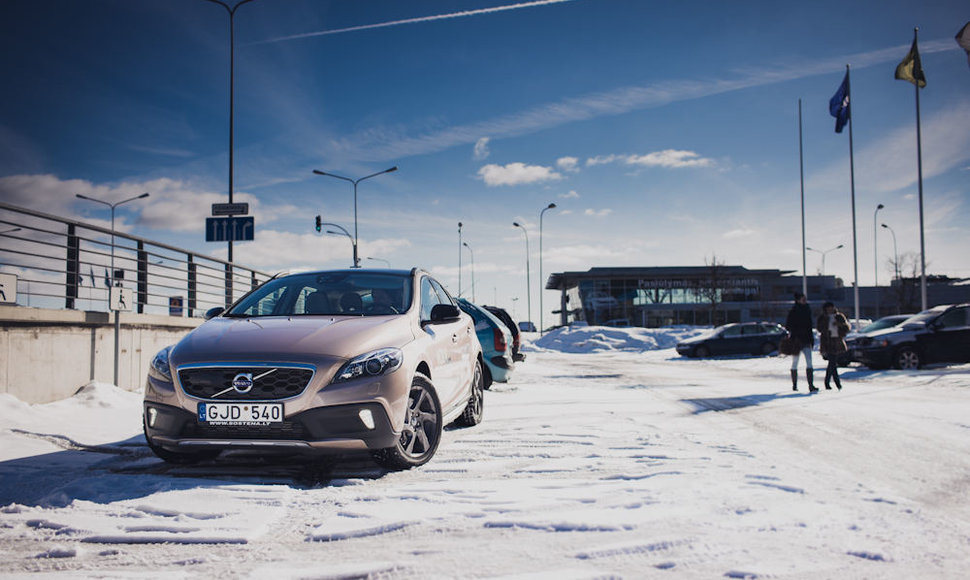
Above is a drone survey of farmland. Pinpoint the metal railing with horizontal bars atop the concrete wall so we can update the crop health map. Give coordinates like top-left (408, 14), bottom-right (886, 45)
top-left (0, 203), bottom-right (271, 318)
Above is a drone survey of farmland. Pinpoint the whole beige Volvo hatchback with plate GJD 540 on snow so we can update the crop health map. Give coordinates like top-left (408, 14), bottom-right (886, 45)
top-left (144, 269), bottom-right (484, 469)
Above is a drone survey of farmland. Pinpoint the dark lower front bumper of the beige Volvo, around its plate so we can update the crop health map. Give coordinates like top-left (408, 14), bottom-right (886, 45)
top-left (144, 401), bottom-right (401, 453)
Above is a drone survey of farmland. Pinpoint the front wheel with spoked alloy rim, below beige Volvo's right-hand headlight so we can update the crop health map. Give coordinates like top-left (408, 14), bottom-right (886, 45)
top-left (372, 374), bottom-right (442, 470)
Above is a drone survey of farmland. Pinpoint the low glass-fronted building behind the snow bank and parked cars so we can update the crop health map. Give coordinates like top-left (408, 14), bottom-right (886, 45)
top-left (546, 265), bottom-right (970, 328)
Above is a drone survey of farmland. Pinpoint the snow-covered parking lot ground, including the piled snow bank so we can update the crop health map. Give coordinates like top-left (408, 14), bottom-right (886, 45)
top-left (0, 327), bottom-right (970, 580)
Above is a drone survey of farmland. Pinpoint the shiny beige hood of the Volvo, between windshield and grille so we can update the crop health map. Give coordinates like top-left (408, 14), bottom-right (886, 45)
top-left (171, 316), bottom-right (414, 365)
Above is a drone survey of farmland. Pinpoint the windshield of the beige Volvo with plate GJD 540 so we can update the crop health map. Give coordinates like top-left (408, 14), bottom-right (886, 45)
top-left (226, 271), bottom-right (411, 317)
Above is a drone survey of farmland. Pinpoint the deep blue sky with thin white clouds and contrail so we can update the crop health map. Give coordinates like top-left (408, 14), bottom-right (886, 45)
top-left (0, 0), bottom-right (970, 322)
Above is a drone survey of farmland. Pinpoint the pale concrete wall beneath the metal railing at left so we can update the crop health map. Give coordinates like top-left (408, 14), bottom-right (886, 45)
top-left (0, 306), bottom-right (202, 403)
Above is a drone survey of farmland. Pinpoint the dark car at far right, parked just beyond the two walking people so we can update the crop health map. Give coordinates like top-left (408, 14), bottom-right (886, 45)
top-left (852, 304), bottom-right (970, 370)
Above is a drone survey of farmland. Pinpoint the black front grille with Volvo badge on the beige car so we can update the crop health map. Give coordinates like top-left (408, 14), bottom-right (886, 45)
top-left (178, 366), bottom-right (313, 401)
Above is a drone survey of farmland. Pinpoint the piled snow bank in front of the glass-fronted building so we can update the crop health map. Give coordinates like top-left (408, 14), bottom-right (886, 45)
top-left (526, 326), bottom-right (710, 353)
